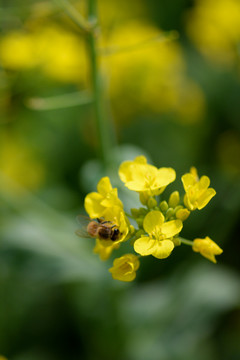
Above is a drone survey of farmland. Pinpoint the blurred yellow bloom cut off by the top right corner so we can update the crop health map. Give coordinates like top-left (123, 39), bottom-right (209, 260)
top-left (186, 0), bottom-right (240, 65)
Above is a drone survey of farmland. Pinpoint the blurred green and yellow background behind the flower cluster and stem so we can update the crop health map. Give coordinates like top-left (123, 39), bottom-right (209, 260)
top-left (0, 0), bottom-right (240, 360)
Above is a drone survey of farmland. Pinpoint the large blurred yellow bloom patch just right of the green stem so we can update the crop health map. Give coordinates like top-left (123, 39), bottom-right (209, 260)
top-left (103, 22), bottom-right (205, 122)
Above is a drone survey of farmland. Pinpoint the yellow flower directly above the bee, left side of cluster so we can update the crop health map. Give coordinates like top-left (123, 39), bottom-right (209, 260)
top-left (84, 176), bottom-right (123, 219)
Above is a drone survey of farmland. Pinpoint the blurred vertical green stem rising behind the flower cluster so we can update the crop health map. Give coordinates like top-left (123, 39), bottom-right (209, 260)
top-left (88, 0), bottom-right (111, 168)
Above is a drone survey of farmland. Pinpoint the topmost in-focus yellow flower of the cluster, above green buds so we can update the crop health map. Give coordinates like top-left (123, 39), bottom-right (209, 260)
top-left (119, 156), bottom-right (176, 196)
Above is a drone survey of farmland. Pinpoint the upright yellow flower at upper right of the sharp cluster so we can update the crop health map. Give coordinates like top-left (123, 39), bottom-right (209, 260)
top-left (182, 167), bottom-right (216, 210)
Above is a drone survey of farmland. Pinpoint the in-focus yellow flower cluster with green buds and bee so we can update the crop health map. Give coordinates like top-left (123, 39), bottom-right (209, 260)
top-left (77, 156), bottom-right (222, 281)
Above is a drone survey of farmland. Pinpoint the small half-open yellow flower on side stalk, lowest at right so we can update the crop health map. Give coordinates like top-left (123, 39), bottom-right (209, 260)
top-left (193, 236), bottom-right (223, 264)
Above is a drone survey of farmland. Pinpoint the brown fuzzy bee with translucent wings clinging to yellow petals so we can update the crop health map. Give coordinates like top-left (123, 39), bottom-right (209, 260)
top-left (75, 215), bottom-right (122, 241)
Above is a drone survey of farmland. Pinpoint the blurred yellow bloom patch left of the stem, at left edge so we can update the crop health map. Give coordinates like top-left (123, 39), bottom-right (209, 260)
top-left (0, 24), bottom-right (88, 84)
